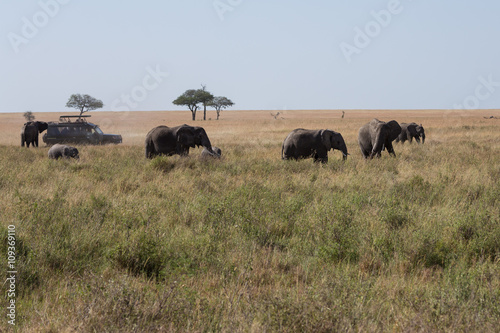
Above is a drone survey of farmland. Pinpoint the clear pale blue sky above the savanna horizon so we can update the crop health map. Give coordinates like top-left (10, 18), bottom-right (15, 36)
top-left (0, 0), bottom-right (500, 112)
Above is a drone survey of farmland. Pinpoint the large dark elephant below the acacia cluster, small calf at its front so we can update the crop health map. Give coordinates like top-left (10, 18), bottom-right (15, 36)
top-left (145, 124), bottom-right (214, 158)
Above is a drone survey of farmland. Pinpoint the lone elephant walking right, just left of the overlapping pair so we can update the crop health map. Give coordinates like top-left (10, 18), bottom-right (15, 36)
top-left (281, 128), bottom-right (349, 163)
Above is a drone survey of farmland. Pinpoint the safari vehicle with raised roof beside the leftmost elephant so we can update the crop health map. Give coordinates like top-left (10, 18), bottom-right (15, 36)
top-left (43, 115), bottom-right (122, 145)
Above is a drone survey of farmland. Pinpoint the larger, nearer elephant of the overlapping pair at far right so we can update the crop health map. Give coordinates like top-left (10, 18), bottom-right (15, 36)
top-left (358, 119), bottom-right (401, 158)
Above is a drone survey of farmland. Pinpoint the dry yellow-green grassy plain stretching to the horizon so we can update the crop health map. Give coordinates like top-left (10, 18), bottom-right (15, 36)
top-left (0, 110), bottom-right (500, 332)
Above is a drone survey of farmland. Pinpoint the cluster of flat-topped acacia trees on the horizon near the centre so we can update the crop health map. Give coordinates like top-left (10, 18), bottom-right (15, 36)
top-left (172, 85), bottom-right (234, 120)
